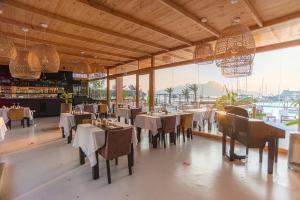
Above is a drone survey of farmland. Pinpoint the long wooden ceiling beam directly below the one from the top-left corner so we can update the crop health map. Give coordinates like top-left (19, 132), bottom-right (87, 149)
top-left (0, 16), bottom-right (150, 55)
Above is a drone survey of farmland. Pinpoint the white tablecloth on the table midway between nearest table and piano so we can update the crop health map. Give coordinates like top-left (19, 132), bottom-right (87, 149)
top-left (134, 112), bottom-right (183, 136)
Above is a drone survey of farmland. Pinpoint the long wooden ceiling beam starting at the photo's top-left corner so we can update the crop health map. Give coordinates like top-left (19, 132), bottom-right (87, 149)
top-left (1, 0), bottom-right (169, 51)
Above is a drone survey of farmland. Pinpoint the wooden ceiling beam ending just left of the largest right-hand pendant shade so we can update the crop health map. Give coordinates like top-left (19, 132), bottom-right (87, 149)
top-left (159, 0), bottom-right (220, 37)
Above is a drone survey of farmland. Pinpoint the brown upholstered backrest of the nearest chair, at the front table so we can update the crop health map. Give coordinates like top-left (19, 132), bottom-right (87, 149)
top-left (103, 127), bottom-right (133, 160)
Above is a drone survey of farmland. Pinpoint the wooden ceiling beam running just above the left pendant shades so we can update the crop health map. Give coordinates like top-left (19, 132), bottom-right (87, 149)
top-left (0, 31), bottom-right (121, 62)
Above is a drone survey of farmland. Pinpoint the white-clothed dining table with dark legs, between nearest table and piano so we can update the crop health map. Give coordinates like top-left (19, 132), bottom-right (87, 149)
top-left (134, 112), bottom-right (188, 148)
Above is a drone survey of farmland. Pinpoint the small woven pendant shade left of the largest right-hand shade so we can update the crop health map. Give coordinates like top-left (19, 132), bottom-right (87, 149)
top-left (194, 43), bottom-right (214, 65)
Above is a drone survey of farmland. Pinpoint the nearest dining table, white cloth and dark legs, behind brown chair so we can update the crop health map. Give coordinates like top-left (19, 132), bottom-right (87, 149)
top-left (73, 121), bottom-right (137, 180)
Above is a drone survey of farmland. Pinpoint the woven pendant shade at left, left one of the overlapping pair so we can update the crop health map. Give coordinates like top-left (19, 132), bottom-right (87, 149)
top-left (9, 51), bottom-right (41, 80)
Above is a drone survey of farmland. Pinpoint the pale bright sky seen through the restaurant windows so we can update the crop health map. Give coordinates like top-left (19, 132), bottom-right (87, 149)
top-left (120, 46), bottom-right (300, 95)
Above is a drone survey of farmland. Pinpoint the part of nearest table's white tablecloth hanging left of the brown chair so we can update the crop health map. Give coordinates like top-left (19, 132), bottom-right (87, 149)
top-left (73, 124), bottom-right (105, 167)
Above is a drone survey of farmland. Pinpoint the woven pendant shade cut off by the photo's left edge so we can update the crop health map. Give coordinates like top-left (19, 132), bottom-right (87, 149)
top-left (0, 35), bottom-right (17, 60)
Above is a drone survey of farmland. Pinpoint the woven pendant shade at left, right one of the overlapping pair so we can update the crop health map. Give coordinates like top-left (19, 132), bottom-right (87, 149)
top-left (28, 44), bottom-right (60, 73)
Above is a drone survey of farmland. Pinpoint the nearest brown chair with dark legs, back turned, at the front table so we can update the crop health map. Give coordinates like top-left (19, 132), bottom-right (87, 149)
top-left (98, 128), bottom-right (133, 184)
